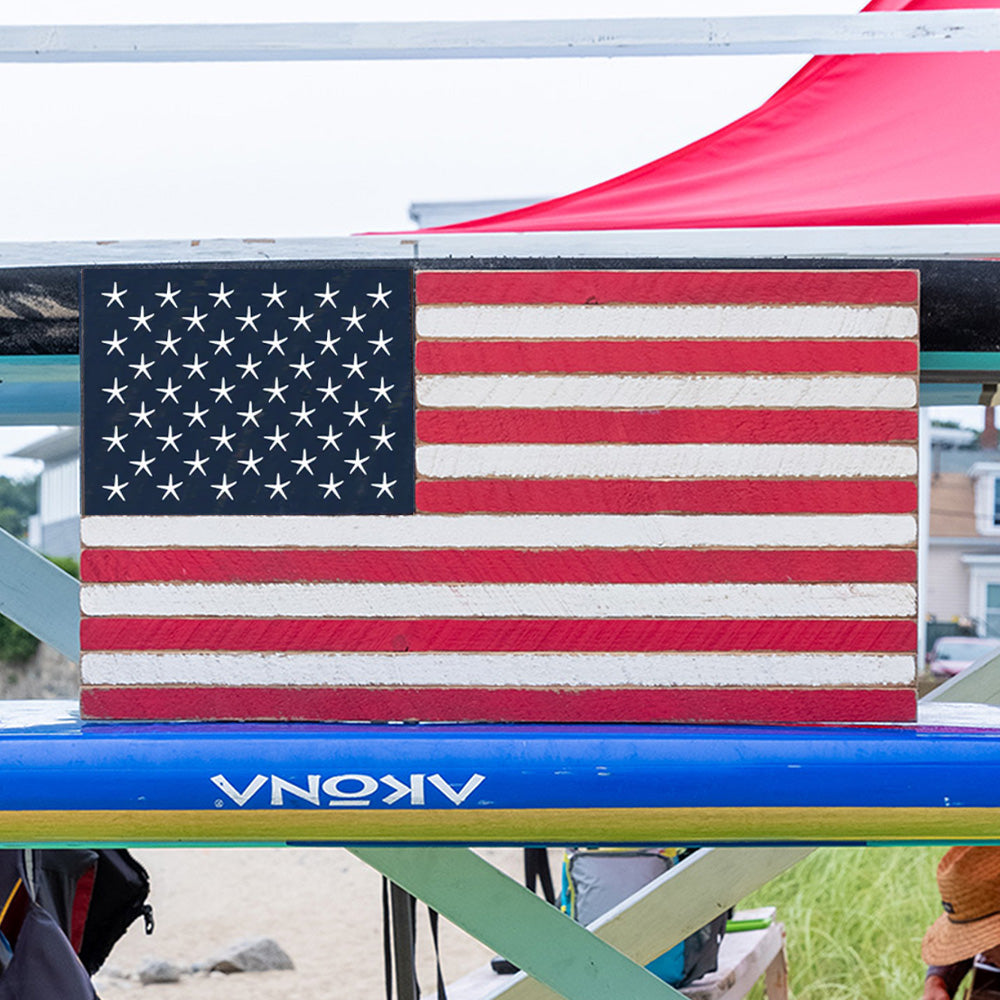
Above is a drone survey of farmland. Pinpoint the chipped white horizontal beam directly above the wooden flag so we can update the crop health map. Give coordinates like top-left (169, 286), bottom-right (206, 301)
top-left (0, 225), bottom-right (1000, 269)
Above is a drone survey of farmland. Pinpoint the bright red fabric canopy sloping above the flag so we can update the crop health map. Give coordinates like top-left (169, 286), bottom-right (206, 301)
top-left (425, 0), bottom-right (1000, 233)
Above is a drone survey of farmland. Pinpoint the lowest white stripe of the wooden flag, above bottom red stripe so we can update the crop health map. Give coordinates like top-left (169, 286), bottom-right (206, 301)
top-left (81, 653), bottom-right (916, 687)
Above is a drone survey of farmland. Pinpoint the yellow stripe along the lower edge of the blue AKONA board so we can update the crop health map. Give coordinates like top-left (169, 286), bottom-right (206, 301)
top-left (0, 807), bottom-right (1000, 846)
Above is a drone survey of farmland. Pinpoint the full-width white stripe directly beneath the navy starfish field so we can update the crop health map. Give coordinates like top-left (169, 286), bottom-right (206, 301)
top-left (81, 516), bottom-right (917, 549)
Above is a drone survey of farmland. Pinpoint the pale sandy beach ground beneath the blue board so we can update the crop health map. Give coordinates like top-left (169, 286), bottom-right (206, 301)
top-left (95, 848), bottom-right (521, 1000)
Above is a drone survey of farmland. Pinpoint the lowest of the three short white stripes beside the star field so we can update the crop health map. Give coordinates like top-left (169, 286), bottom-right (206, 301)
top-left (417, 444), bottom-right (917, 479)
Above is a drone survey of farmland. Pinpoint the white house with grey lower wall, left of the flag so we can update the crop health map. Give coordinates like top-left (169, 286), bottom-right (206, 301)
top-left (12, 427), bottom-right (80, 558)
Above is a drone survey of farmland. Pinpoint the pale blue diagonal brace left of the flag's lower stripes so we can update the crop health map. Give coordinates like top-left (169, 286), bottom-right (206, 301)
top-left (0, 528), bottom-right (80, 660)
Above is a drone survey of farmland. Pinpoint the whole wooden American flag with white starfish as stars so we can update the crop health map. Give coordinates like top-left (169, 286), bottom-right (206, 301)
top-left (82, 265), bottom-right (918, 721)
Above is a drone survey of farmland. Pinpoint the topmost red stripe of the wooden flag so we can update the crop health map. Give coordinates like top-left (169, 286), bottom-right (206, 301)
top-left (416, 271), bottom-right (918, 305)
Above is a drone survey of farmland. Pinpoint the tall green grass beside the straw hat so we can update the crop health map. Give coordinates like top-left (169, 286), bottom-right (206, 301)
top-left (740, 847), bottom-right (946, 1000)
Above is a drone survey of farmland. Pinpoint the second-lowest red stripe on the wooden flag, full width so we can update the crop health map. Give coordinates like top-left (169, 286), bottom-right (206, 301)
top-left (80, 618), bottom-right (917, 653)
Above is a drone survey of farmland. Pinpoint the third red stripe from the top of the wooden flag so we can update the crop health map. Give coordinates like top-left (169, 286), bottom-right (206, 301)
top-left (417, 409), bottom-right (917, 444)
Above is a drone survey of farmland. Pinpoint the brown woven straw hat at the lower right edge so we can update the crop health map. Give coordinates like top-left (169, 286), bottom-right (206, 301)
top-left (921, 847), bottom-right (1000, 965)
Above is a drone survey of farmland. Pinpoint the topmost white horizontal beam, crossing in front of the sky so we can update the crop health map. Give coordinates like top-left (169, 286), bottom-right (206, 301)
top-left (0, 10), bottom-right (1000, 63)
